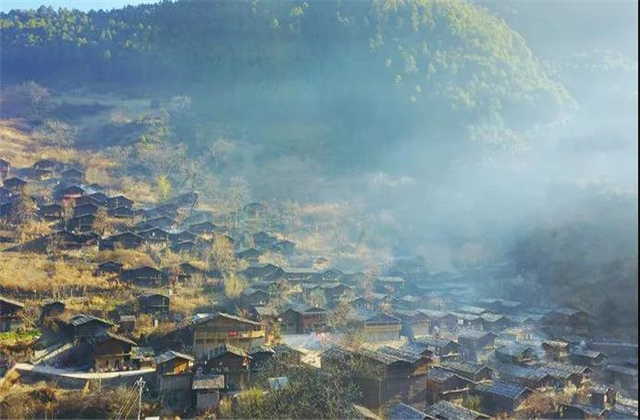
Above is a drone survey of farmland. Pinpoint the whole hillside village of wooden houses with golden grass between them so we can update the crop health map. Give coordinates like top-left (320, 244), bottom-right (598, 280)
top-left (0, 158), bottom-right (638, 420)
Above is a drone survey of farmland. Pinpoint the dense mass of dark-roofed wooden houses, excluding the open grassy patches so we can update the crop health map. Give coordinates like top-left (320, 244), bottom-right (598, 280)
top-left (0, 159), bottom-right (638, 420)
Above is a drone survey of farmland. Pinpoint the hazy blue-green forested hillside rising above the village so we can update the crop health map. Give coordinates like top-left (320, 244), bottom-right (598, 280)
top-left (0, 0), bottom-right (569, 164)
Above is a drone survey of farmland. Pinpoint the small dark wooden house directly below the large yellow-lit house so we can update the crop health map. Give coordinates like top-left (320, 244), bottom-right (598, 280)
top-left (205, 344), bottom-right (251, 391)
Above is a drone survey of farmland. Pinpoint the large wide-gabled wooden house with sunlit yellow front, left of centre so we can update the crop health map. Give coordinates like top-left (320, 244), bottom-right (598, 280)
top-left (192, 312), bottom-right (265, 358)
